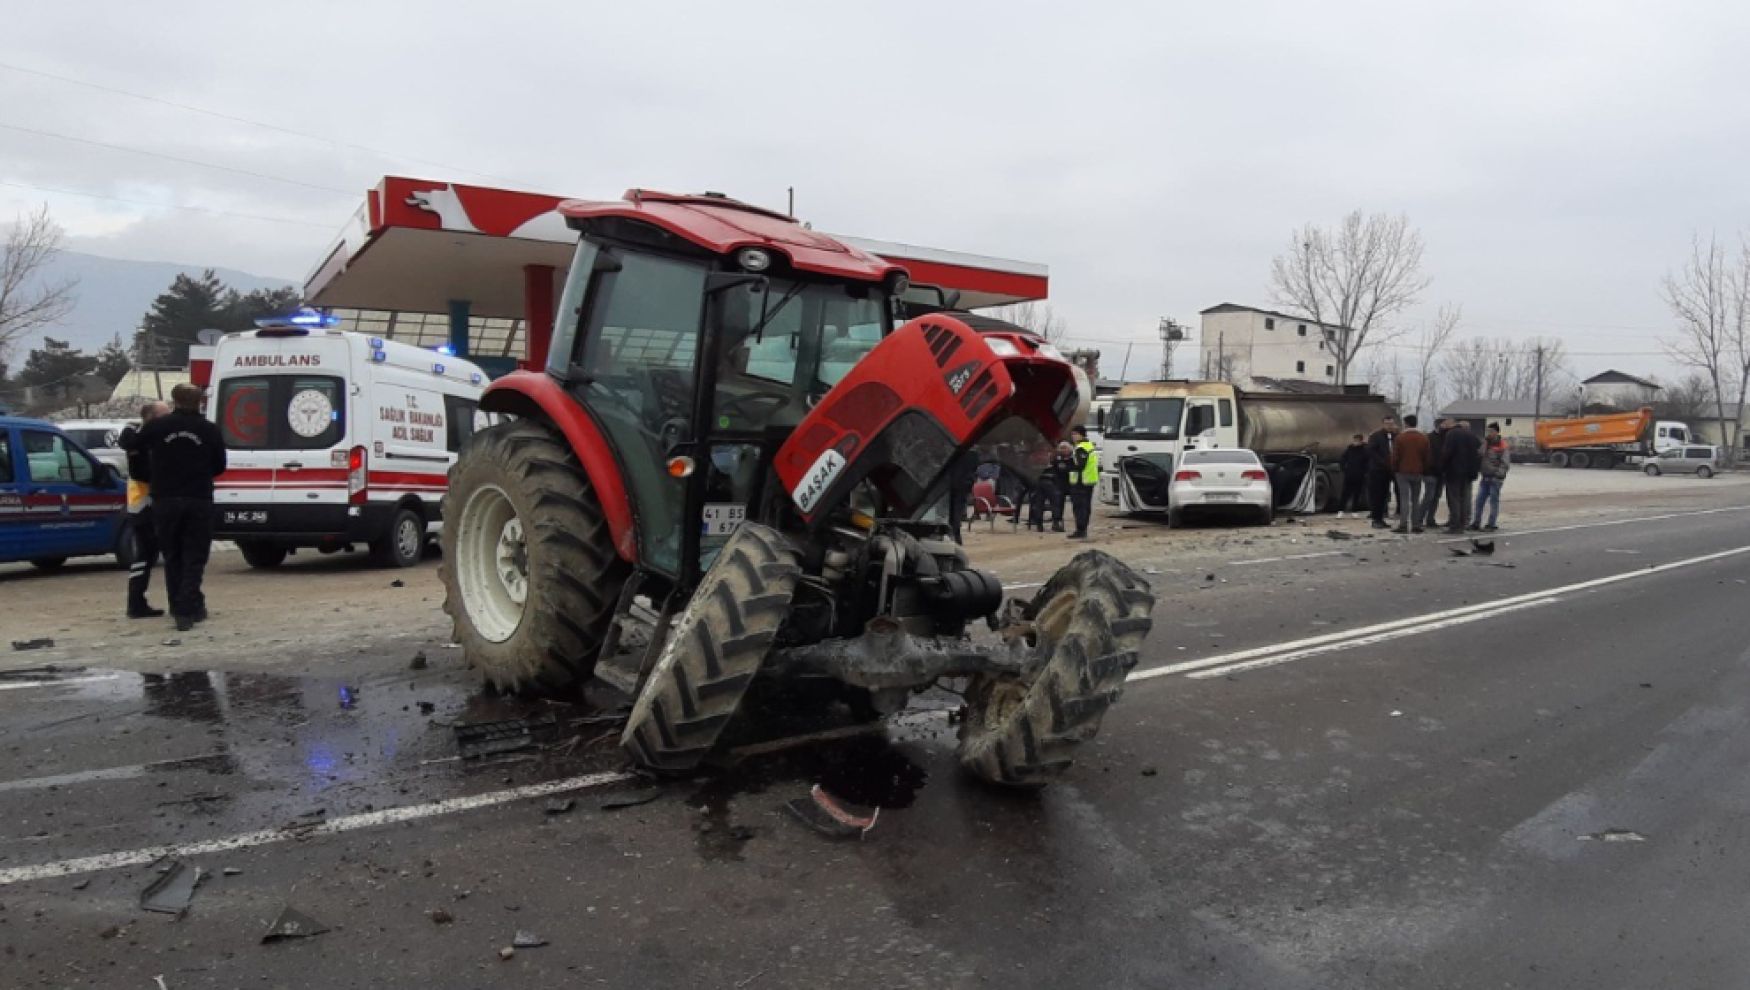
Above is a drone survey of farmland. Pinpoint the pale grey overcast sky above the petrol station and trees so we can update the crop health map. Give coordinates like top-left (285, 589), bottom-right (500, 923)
top-left (0, 0), bottom-right (1750, 388)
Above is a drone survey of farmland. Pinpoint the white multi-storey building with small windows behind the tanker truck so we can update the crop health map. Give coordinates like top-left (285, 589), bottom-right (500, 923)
top-left (1197, 303), bottom-right (1337, 388)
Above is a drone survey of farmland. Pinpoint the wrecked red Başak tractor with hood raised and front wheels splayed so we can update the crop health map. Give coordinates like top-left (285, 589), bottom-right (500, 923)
top-left (443, 189), bottom-right (1153, 785)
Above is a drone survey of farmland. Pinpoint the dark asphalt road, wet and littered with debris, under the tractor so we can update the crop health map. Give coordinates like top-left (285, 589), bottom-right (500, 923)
top-left (0, 488), bottom-right (1750, 990)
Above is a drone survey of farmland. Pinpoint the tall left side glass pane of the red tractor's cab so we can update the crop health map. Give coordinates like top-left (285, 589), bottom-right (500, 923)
top-left (579, 254), bottom-right (705, 574)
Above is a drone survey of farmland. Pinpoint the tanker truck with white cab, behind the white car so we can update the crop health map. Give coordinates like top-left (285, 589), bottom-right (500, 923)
top-left (1099, 381), bottom-right (1395, 514)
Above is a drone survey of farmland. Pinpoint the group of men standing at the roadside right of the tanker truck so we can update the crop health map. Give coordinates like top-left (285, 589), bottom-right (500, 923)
top-left (1339, 415), bottom-right (1512, 533)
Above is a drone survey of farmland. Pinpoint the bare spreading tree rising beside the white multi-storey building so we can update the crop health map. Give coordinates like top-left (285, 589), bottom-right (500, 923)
top-left (1271, 210), bottom-right (1428, 385)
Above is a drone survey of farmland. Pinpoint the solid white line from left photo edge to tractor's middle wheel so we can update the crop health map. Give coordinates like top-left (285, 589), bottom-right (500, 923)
top-left (0, 771), bottom-right (639, 887)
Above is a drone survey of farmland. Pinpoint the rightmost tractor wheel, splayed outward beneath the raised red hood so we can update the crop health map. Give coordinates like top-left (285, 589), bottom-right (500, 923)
top-left (959, 549), bottom-right (1155, 787)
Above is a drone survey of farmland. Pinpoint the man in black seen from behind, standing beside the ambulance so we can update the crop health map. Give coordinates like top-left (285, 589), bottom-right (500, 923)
top-left (135, 385), bottom-right (226, 631)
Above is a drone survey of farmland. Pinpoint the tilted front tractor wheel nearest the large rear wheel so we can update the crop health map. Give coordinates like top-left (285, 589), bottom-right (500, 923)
top-left (620, 523), bottom-right (802, 771)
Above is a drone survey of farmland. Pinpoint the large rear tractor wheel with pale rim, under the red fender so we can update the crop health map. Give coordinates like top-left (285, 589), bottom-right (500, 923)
top-left (439, 420), bottom-right (628, 691)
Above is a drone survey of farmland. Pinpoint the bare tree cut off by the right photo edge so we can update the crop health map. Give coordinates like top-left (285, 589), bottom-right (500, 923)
top-left (1663, 234), bottom-right (1747, 450)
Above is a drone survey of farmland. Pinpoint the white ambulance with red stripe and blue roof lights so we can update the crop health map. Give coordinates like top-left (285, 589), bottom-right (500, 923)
top-left (207, 310), bottom-right (487, 567)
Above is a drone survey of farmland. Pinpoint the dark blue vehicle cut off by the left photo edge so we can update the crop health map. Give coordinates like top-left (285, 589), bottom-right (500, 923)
top-left (0, 416), bottom-right (133, 570)
